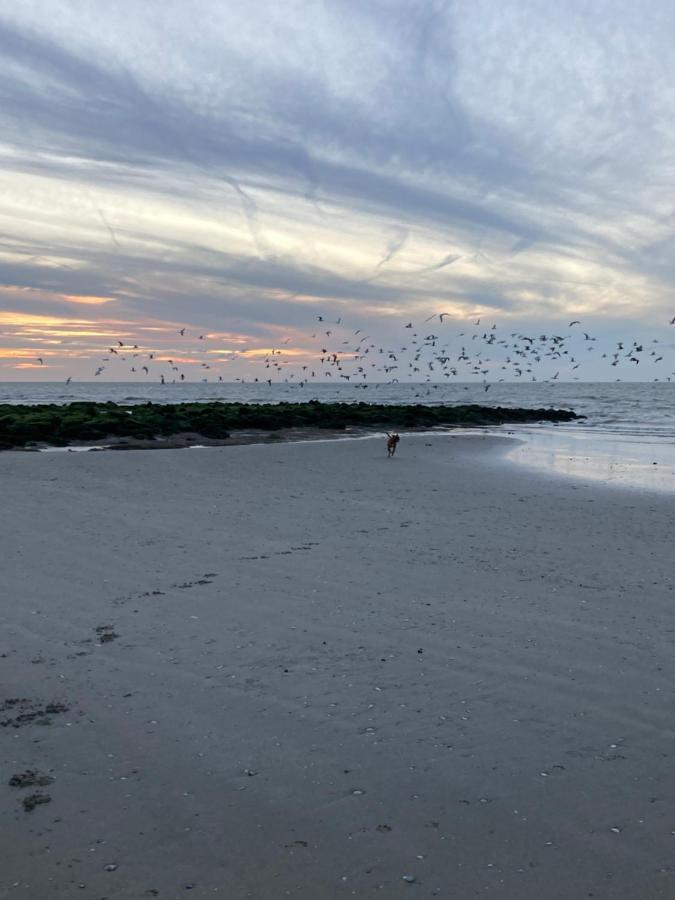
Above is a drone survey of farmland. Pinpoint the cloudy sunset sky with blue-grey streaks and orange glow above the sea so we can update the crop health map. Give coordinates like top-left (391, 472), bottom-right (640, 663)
top-left (0, 0), bottom-right (675, 381)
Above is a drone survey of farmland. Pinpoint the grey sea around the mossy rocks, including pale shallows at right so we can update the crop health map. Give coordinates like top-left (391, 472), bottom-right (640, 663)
top-left (0, 381), bottom-right (675, 493)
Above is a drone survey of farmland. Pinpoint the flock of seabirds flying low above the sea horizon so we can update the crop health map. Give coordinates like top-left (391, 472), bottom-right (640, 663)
top-left (37, 312), bottom-right (675, 391)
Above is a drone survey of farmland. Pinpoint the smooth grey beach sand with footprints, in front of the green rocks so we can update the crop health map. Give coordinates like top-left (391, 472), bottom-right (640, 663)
top-left (0, 436), bottom-right (675, 900)
